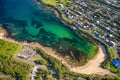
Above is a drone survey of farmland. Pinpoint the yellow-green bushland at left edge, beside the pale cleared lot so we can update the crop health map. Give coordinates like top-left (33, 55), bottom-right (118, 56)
top-left (0, 39), bottom-right (30, 80)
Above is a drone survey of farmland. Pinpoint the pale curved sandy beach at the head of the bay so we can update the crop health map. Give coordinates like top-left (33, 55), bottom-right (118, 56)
top-left (71, 45), bottom-right (112, 75)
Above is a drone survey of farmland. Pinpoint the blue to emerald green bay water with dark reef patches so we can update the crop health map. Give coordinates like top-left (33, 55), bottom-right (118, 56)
top-left (0, 0), bottom-right (96, 60)
